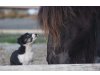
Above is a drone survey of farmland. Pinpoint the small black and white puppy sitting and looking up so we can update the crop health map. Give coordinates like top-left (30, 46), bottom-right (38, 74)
top-left (10, 33), bottom-right (37, 65)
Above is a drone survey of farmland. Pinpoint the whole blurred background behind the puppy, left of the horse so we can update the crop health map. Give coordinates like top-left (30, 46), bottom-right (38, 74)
top-left (0, 6), bottom-right (47, 65)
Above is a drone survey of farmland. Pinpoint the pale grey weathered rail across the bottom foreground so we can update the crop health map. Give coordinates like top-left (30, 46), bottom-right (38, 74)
top-left (0, 64), bottom-right (100, 71)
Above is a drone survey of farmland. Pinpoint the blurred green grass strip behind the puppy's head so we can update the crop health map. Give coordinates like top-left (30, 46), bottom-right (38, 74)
top-left (0, 34), bottom-right (47, 43)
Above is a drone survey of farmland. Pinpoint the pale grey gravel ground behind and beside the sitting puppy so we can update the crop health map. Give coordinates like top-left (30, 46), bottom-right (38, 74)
top-left (0, 43), bottom-right (47, 65)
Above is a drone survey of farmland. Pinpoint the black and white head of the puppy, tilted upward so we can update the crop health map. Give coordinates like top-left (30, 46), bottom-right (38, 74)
top-left (17, 33), bottom-right (37, 45)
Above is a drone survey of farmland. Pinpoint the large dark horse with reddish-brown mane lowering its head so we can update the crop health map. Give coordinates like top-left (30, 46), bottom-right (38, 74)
top-left (38, 6), bottom-right (100, 64)
